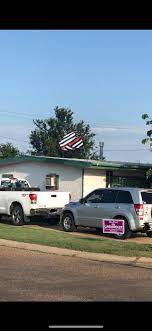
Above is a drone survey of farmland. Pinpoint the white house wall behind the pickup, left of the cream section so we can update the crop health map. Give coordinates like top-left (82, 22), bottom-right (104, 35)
top-left (0, 162), bottom-right (82, 201)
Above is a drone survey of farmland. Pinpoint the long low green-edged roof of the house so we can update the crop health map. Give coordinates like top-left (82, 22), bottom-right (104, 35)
top-left (0, 155), bottom-right (152, 170)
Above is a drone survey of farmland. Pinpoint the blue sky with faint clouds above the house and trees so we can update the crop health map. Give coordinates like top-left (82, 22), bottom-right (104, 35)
top-left (0, 30), bottom-right (152, 163)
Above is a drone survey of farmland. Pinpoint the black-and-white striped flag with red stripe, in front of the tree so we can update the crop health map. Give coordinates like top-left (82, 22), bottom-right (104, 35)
top-left (59, 131), bottom-right (83, 151)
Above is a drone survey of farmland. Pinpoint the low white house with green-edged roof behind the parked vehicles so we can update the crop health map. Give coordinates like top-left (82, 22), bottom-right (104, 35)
top-left (0, 155), bottom-right (152, 201)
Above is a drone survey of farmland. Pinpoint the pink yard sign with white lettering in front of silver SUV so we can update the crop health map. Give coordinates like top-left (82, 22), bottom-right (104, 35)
top-left (103, 219), bottom-right (125, 234)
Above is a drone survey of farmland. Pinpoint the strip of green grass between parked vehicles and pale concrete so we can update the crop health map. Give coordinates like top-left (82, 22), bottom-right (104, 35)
top-left (0, 223), bottom-right (152, 257)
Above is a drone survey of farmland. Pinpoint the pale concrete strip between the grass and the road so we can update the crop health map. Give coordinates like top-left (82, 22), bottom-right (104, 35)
top-left (0, 239), bottom-right (152, 269)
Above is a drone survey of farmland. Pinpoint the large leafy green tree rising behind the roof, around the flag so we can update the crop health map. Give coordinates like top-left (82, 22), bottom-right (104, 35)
top-left (30, 106), bottom-right (101, 159)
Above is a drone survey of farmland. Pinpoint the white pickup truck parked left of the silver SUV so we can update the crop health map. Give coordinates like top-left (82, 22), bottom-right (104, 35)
top-left (0, 178), bottom-right (70, 225)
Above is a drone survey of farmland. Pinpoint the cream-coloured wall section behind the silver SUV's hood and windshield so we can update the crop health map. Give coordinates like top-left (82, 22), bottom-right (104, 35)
top-left (83, 169), bottom-right (106, 196)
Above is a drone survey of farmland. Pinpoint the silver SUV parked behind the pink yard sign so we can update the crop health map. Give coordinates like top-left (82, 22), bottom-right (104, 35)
top-left (60, 187), bottom-right (152, 239)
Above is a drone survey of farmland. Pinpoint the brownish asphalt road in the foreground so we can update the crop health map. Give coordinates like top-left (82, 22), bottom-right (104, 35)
top-left (0, 246), bottom-right (152, 301)
